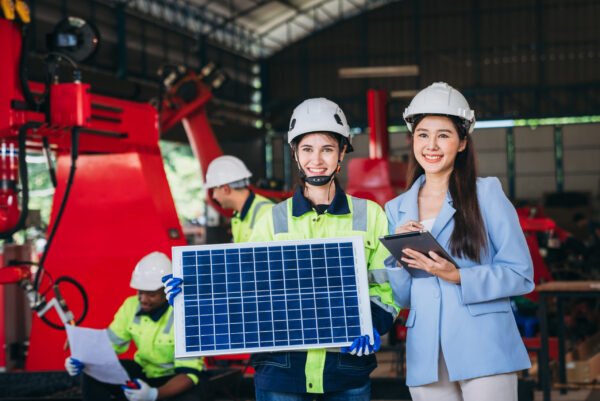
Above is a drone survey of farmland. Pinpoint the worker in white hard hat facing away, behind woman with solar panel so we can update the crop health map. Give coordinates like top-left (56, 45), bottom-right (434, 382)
top-left (204, 156), bottom-right (273, 243)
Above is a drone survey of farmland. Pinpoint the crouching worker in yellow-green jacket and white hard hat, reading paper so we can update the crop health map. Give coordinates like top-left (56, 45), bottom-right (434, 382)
top-left (65, 252), bottom-right (204, 401)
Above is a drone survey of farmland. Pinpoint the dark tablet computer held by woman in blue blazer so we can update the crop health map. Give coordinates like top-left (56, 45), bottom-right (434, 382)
top-left (379, 231), bottom-right (458, 277)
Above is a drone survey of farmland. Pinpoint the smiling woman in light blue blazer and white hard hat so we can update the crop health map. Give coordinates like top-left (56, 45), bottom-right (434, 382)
top-left (385, 82), bottom-right (534, 401)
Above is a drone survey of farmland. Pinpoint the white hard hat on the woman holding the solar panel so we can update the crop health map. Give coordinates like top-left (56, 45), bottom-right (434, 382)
top-left (288, 97), bottom-right (352, 152)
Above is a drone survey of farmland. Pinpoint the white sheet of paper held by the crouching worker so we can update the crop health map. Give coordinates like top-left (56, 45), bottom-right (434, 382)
top-left (66, 325), bottom-right (129, 384)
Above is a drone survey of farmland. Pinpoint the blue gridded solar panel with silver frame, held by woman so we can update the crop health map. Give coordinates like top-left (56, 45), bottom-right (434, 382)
top-left (173, 237), bottom-right (373, 357)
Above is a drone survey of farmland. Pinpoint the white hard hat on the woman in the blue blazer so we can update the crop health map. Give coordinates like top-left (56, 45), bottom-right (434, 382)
top-left (402, 82), bottom-right (475, 133)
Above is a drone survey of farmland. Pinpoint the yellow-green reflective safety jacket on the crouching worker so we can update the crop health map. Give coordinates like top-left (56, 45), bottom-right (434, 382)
top-left (107, 295), bottom-right (204, 384)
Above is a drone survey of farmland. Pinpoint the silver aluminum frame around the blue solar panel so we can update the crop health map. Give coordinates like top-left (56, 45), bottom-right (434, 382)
top-left (172, 236), bottom-right (373, 358)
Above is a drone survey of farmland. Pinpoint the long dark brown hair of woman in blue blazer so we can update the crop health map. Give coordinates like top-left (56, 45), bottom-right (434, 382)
top-left (407, 114), bottom-right (488, 262)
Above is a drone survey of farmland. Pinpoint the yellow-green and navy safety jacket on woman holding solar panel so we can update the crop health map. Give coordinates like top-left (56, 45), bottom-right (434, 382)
top-left (250, 188), bottom-right (399, 393)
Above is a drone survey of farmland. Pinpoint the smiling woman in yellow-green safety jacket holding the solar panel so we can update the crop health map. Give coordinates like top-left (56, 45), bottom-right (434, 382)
top-left (166, 98), bottom-right (398, 401)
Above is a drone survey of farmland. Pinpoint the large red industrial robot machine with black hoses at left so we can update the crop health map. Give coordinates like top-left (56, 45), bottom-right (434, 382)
top-left (0, 4), bottom-right (282, 371)
